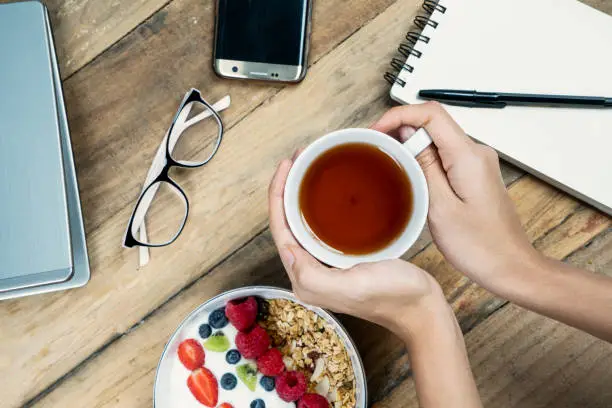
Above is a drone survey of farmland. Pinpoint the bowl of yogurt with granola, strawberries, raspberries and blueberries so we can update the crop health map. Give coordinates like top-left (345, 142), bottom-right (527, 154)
top-left (153, 286), bottom-right (367, 408)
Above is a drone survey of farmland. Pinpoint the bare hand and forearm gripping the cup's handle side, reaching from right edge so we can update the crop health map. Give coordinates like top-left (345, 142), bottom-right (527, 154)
top-left (372, 103), bottom-right (612, 342)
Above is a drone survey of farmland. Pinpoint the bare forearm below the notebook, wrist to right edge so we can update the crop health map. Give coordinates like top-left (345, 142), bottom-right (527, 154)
top-left (493, 256), bottom-right (612, 342)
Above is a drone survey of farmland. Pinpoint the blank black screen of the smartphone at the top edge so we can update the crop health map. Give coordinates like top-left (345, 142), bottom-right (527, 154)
top-left (216, 0), bottom-right (308, 65)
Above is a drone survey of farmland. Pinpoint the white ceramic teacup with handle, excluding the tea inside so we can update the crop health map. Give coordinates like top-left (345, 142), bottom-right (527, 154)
top-left (284, 129), bottom-right (431, 268)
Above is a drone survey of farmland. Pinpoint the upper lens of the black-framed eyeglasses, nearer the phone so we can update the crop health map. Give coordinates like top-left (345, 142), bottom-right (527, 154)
top-left (170, 102), bottom-right (221, 165)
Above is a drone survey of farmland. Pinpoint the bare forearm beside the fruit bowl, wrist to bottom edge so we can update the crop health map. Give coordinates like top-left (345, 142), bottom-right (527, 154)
top-left (398, 300), bottom-right (482, 408)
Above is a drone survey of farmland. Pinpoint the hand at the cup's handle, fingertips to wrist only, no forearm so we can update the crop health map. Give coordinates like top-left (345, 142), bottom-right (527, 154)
top-left (372, 102), bottom-right (541, 293)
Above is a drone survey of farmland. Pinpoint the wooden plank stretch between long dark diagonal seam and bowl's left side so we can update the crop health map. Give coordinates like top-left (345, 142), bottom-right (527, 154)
top-left (34, 233), bottom-right (290, 408)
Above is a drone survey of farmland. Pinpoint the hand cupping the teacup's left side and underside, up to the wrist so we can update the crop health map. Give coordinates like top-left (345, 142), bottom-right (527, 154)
top-left (269, 160), bottom-right (452, 337)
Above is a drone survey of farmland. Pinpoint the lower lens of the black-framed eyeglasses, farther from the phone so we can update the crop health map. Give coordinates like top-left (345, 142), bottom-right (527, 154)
top-left (132, 181), bottom-right (187, 245)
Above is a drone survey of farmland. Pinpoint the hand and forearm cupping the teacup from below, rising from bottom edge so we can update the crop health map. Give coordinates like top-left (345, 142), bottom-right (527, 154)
top-left (269, 151), bottom-right (482, 408)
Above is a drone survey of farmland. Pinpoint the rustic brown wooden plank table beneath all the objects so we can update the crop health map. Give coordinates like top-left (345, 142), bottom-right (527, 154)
top-left (0, 0), bottom-right (612, 408)
